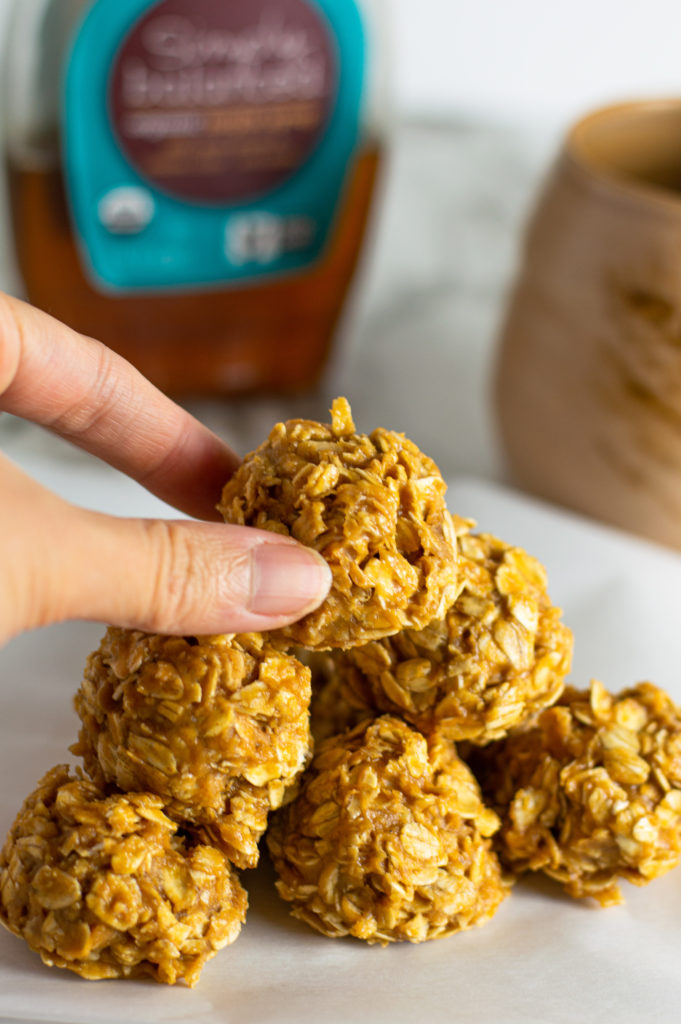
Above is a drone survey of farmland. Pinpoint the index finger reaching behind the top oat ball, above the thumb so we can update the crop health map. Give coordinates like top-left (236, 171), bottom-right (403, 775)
top-left (0, 294), bottom-right (239, 519)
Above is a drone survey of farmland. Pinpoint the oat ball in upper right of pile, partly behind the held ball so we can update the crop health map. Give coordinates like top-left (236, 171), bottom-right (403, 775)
top-left (331, 519), bottom-right (572, 743)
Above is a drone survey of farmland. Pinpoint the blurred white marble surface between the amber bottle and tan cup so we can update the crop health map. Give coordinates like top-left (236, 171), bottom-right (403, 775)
top-left (0, 122), bottom-right (558, 499)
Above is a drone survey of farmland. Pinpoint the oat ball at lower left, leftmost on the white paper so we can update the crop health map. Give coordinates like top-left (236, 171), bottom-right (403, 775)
top-left (0, 765), bottom-right (247, 985)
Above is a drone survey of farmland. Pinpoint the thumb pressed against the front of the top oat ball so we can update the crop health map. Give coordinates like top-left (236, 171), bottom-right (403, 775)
top-left (0, 468), bottom-right (331, 640)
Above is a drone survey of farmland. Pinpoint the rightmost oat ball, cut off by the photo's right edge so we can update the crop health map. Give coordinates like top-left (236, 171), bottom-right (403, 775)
top-left (475, 682), bottom-right (681, 906)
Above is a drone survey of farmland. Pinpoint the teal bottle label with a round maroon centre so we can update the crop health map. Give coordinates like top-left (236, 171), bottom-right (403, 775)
top-left (62, 0), bottom-right (366, 291)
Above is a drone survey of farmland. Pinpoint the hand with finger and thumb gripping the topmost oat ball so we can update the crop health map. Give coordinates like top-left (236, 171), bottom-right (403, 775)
top-left (0, 295), bottom-right (331, 644)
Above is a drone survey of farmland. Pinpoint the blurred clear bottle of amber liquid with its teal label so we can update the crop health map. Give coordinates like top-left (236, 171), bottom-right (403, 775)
top-left (5, 0), bottom-right (384, 394)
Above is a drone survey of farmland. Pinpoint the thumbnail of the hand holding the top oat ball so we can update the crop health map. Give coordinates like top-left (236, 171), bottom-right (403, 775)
top-left (249, 544), bottom-right (331, 616)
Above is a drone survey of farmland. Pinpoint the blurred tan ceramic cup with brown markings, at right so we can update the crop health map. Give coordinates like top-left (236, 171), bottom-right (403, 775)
top-left (495, 99), bottom-right (681, 548)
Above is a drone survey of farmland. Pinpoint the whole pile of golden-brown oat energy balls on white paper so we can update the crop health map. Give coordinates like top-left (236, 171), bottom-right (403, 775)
top-left (0, 398), bottom-right (681, 985)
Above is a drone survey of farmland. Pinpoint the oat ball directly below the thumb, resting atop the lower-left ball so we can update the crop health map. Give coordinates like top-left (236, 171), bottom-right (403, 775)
top-left (73, 629), bottom-right (311, 867)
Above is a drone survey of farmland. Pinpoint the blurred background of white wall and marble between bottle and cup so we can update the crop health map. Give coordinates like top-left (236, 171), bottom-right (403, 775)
top-left (0, 0), bottom-right (681, 499)
